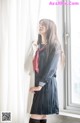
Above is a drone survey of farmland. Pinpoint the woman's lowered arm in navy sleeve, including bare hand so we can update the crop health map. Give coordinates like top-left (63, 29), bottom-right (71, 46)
top-left (30, 52), bottom-right (59, 93)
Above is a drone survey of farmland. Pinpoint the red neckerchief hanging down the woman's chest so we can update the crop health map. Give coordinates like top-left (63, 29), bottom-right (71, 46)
top-left (33, 46), bottom-right (45, 73)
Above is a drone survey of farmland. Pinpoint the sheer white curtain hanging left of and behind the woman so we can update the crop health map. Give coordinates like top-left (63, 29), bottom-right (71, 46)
top-left (0, 0), bottom-right (56, 123)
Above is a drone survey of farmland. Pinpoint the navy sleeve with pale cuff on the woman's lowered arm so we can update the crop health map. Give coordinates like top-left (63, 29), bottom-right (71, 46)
top-left (39, 46), bottom-right (60, 87)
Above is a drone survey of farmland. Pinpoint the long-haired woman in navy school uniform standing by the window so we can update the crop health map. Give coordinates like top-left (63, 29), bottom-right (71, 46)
top-left (24, 19), bottom-right (62, 123)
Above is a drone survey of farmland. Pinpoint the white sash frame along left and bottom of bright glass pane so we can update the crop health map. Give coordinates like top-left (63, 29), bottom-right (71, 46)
top-left (63, 0), bottom-right (80, 114)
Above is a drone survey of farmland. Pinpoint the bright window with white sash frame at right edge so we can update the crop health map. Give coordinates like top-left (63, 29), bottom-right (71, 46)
top-left (63, 0), bottom-right (80, 113)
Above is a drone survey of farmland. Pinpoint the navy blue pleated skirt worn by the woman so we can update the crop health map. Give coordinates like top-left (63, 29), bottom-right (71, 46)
top-left (30, 77), bottom-right (59, 115)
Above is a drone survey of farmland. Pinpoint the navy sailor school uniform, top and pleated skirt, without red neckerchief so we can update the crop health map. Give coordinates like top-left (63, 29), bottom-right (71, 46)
top-left (24, 44), bottom-right (60, 115)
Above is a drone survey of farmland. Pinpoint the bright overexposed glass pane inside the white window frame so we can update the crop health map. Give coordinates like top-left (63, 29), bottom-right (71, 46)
top-left (71, 6), bottom-right (80, 105)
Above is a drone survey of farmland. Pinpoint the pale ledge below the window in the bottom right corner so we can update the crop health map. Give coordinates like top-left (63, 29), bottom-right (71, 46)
top-left (47, 115), bottom-right (80, 123)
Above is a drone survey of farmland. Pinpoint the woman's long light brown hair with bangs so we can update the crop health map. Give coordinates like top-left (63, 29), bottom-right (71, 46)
top-left (37, 19), bottom-right (63, 65)
